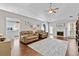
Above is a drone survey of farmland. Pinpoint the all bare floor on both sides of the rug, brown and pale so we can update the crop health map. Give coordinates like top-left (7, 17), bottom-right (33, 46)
top-left (12, 36), bottom-right (78, 56)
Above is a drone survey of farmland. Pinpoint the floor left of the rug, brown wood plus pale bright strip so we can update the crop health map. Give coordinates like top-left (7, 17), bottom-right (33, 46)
top-left (11, 39), bottom-right (41, 56)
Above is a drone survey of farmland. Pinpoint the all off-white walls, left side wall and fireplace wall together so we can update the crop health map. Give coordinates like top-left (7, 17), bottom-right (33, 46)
top-left (0, 10), bottom-right (76, 37)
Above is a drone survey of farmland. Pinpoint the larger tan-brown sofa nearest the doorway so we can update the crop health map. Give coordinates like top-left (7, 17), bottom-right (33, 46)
top-left (20, 31), bottom-right (39, 44)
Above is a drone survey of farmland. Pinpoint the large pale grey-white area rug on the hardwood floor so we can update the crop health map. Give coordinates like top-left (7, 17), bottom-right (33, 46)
top-left (28, 38), bottom-right (68, 56)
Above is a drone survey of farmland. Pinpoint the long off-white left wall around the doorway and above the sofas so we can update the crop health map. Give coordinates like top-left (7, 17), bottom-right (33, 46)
top-left (0, 10), bottom-right (42, 35)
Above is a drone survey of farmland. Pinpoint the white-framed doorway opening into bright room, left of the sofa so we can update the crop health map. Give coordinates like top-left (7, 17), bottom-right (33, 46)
top-left (6, 18), bottom-right (20, 39)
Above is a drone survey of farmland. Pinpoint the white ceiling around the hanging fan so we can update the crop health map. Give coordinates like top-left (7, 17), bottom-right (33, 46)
top-left (0, 3), bottom-right (79, 22)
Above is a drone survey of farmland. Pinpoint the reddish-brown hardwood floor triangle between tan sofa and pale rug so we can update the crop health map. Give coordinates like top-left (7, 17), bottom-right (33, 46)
top-left (20, 43), bottom-right (41, 56)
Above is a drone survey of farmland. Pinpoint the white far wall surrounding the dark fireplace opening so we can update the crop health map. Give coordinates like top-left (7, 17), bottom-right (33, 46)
top-left (49, 20), bottom-right (76, 37)
